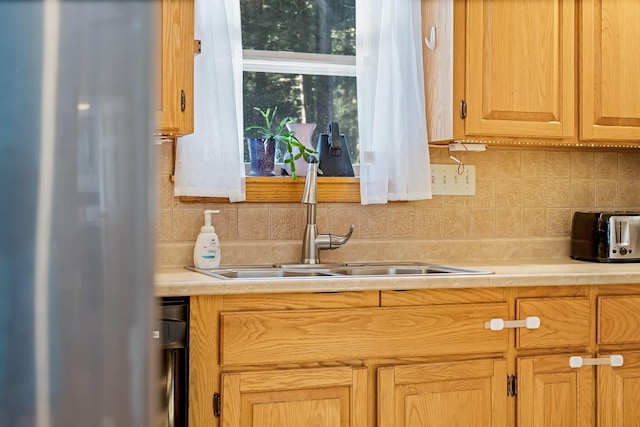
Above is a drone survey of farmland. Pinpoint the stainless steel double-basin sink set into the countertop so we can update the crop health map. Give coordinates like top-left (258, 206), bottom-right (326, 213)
top-left (186, 263), bottom-right (493, 280)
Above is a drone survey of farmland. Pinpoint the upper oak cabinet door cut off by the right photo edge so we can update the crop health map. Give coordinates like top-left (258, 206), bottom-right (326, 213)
top-left (580, 0), bottom-right (640, 140)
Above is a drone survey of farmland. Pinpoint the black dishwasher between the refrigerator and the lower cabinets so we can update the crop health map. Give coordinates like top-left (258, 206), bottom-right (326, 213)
top-left (153, 297), bottom-right (189, 427)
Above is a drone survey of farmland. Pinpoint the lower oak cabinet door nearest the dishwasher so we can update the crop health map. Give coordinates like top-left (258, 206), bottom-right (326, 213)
top-left (221, 367), bottom-right (367, 427)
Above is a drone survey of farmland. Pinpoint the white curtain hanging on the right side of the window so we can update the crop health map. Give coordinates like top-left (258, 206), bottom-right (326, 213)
top-left (356, 0), bottom-right (431, 205)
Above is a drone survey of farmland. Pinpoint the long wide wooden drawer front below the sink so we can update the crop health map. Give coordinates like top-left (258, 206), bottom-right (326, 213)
top-left (221, 303), bottom-right (508, 366)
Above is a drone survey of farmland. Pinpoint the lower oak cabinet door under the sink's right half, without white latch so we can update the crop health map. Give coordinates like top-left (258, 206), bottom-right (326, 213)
top-left (378, 360), bottom-right (507, 427)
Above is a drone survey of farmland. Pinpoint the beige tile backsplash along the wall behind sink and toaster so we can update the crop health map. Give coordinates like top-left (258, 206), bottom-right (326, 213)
top-left (156, 143), bottom-right (640, 267)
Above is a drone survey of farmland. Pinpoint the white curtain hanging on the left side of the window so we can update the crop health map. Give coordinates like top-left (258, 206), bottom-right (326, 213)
top-left (174, 0), bottom-right (245, 202)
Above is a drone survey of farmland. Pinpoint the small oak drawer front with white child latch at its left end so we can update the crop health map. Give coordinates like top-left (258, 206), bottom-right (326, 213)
top-left (517, 298), bottom-right (590, 348)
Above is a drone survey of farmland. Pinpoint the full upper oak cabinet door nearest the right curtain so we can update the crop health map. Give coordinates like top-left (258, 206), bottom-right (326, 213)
top-left (465, 0), bottom-right (576, 138)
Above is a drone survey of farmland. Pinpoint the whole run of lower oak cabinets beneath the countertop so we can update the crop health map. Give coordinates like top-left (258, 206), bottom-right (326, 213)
top-left (189, 285), bottom-right (640, 427)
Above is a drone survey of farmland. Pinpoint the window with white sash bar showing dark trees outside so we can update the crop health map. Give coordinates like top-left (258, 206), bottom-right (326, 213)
top-left (240, 0), bottom-right (359, 163)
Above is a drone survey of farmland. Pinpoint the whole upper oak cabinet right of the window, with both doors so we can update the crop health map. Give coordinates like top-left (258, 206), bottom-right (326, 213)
top-left (422, 0), bottom-right (640, 146)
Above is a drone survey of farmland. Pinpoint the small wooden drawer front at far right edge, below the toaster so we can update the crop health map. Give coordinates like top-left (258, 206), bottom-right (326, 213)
top-left (598, 296), bottom-right (640, 344)
